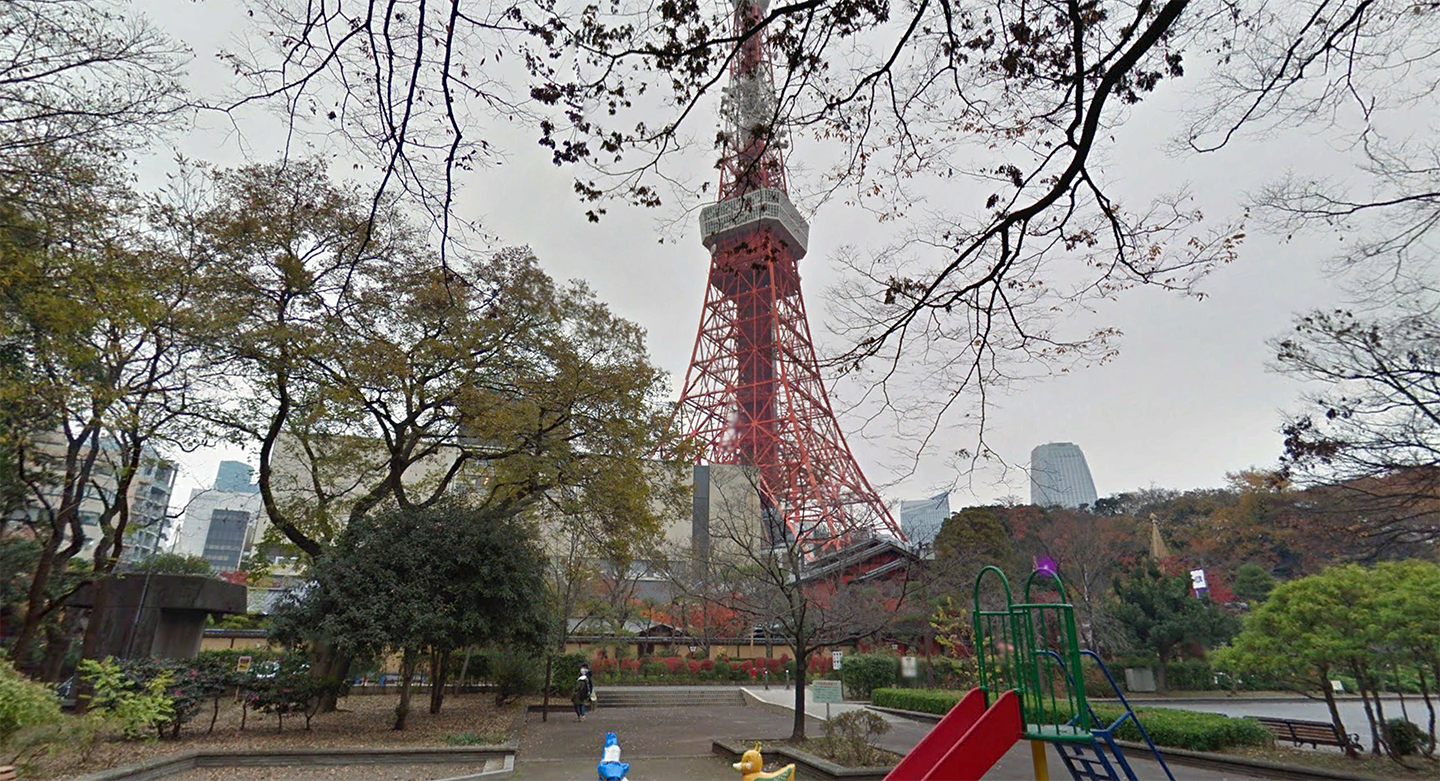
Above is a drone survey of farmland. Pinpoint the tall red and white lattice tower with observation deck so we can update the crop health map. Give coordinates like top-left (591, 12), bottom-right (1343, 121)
top-left (677, 0), bottom-right (903, 549)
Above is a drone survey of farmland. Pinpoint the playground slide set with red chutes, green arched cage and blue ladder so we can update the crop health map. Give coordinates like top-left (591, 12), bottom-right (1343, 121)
top-left (881, 566), bottom-right (1175, 781)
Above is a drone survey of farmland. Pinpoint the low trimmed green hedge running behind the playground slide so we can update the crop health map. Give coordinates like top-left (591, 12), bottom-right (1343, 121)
top-left (871, 689), bottom-right (1272, 751)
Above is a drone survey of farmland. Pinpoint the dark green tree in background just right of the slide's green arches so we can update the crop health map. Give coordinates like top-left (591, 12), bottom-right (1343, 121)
top-left (1115, 561), bottom-right (1240, 690)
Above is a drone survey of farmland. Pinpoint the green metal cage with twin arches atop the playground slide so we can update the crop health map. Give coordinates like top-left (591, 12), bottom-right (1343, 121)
top-left (972, 566), bottom-right (1097, 742)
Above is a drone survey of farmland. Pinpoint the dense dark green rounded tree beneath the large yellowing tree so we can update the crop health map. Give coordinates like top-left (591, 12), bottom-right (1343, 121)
top-left (275, 500), bottom-right (546, 729)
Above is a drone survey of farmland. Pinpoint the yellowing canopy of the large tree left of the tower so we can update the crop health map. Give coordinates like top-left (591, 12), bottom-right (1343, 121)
top-left (168, 160), bottom-right (682, 558)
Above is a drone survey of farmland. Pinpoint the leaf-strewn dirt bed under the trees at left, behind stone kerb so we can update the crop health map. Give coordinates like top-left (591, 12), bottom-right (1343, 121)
top-left (30, 695), bottom-right (524, 780)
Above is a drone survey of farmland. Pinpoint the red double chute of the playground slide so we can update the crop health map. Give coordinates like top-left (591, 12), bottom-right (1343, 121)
top-left (886, 689), bottom-right (1022, 781)
